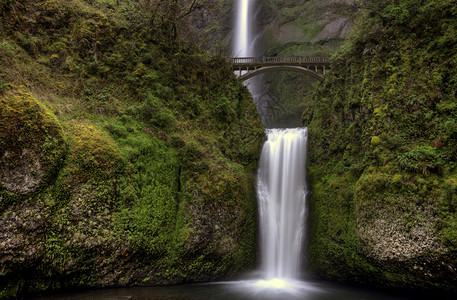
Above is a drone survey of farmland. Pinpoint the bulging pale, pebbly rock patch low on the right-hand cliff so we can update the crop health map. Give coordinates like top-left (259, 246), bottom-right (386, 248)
top-left (355, 170), bottom-right (449, 262)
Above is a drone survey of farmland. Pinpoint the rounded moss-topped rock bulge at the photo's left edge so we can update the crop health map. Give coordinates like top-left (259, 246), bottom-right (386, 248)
top-left (0, 87), bottom-right (65, 195)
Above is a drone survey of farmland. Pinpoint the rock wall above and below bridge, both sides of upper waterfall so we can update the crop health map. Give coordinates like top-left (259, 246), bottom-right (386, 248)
top-left (184, 0), bottom-right (353, 127)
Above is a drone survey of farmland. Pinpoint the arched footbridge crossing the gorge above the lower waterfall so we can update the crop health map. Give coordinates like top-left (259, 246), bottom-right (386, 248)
top-left (230, 56), bottom-right (330, 81)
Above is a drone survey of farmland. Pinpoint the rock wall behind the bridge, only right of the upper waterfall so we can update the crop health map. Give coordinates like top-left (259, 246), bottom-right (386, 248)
top-left (249, 0), bottom-right (352, 127)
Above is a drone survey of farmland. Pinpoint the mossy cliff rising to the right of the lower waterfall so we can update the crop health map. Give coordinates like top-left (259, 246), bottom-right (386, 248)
top-left (304, 0), bottom-right (457, 290)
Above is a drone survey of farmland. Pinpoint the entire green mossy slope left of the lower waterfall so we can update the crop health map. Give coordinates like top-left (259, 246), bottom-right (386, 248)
top-left (0, 0), bottom-right (263, 298)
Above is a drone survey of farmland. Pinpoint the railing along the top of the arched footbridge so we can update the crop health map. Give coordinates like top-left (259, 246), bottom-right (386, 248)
top-left (230, 56), bottom-right (330, 66)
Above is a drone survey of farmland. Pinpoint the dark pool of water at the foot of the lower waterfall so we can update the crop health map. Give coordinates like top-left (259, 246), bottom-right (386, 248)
top-left (30, 280), bottom-right (428, 300)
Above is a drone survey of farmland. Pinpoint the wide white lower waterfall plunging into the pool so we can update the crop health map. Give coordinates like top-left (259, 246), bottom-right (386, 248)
top-left (257, 128), bottom-right (308, 280)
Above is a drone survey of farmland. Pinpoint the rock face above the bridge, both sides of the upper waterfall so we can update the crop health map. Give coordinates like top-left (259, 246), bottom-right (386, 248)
top-left (184, 0), bottom-right (352, 55)
